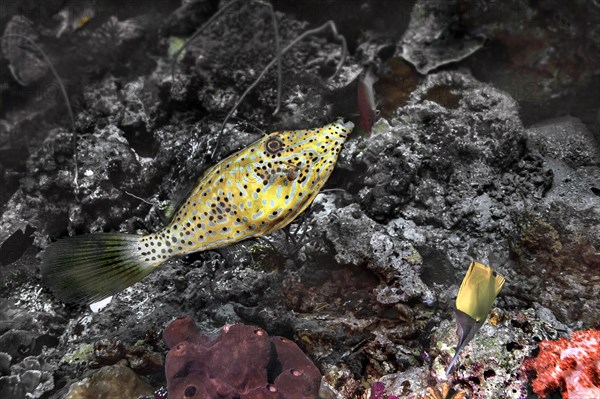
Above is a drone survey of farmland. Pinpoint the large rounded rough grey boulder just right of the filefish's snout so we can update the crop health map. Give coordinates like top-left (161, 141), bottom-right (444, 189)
top-left (338, 72), bottom-right (551, 230)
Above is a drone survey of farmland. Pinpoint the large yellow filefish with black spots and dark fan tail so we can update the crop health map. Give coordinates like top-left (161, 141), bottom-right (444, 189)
top-left (42, 121), bottom-right (354, 303)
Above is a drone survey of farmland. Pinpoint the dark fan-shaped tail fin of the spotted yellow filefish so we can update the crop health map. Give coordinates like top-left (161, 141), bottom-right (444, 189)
top-left (42, 233), bottom-right (166, 304)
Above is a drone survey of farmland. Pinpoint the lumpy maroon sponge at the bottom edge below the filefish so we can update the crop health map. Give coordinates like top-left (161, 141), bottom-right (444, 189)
top-left (164, 317), bottom-right (321, 399)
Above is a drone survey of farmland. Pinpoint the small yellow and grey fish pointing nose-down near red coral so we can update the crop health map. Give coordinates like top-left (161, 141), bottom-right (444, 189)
top-left (446, 262), bottom-right (506, 374)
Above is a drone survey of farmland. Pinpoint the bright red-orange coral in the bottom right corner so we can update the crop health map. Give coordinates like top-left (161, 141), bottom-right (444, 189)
top-left (523, 330), bottom-right (600, 399)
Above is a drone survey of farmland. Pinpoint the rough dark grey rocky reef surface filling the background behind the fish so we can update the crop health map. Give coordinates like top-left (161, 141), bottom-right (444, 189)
top-left (0, 0), bottom-right (600, 399)
